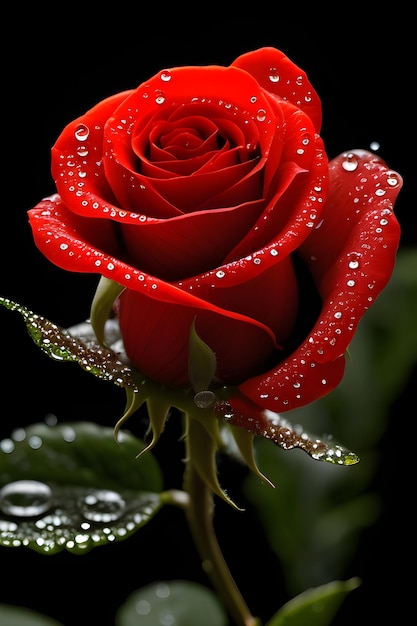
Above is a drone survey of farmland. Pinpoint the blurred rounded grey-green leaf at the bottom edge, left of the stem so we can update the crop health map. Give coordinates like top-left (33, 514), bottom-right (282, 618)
top-left (115, 580), bottom-right (229, 626)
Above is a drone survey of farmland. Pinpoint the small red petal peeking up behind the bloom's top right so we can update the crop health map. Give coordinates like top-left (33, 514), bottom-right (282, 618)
top-left (232, 46), bottom-right (322, 133)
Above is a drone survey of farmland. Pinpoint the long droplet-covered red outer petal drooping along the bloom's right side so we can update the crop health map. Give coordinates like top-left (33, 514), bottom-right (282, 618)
top-left (232, 151), bottom-right (402, 412)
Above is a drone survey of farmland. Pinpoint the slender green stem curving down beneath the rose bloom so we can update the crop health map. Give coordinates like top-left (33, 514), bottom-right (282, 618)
top-left (184, 412), bottom-right (260, 626)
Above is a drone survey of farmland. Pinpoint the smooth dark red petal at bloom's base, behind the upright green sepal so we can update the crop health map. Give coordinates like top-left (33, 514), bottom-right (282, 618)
top-left (117, 290), bottom-right (282, 386)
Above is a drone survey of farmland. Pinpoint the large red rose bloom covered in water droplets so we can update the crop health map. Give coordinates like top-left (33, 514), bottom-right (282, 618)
top-left (29, 47), bottom-right (402, 420)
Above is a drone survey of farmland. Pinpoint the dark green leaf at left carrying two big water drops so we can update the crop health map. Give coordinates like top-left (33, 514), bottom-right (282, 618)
top-left (0, 422), bottom-right (162, 554)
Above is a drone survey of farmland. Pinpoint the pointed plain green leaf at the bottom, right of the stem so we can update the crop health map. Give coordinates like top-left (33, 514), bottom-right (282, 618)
top-left (265, 578), bottom-right (360, 626)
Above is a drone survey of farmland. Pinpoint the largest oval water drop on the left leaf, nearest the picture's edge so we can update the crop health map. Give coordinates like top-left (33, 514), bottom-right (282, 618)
top-left (0, 480), bottom-right (52, 517)
